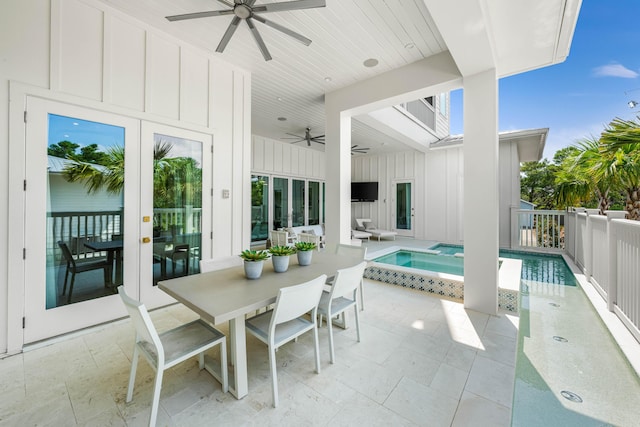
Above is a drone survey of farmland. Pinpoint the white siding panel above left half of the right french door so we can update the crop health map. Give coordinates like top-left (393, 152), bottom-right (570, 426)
top-left (146, 33), bottom-right (180, 119)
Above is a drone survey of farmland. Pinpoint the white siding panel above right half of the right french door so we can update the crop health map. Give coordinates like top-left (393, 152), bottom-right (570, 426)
top-left (180, 48), bottom-right (209, 126)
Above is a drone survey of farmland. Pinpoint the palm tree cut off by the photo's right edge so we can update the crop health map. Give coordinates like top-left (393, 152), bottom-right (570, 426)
top-left (600, 118), bottom-right (640, 221)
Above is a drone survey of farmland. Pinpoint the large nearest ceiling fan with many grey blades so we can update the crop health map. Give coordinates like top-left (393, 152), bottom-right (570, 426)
top-left (166, 0), bottom-right (326, 61)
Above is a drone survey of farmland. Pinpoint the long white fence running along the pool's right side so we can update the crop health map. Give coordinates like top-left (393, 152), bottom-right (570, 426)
top-left (565, 209), bottom-right (640, 341)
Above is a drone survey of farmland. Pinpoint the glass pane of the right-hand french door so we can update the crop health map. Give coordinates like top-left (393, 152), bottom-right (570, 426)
top-left (152, 133), bottom-right (202, 286)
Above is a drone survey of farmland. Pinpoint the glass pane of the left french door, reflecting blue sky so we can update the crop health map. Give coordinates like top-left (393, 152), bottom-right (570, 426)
top-left (46, 113), bottom-right (125, 309)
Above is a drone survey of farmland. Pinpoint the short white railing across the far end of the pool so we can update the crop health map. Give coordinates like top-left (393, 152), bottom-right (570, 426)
top-left (511, 208), bottom-right (565, 251)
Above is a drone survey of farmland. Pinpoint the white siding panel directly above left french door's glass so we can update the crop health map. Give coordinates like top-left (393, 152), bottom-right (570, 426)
top-left (57, 0), bottom-right (104, 100)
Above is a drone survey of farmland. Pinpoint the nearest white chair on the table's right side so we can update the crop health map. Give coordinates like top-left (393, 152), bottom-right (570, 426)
top-left (246, 274), bottom-right (327, 408)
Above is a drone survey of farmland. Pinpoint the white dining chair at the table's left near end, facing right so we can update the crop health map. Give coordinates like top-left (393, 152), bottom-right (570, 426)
top-left (118, 286), bottom-right (229, 426)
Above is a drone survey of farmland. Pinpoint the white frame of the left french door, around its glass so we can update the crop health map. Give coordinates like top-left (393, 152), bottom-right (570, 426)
top-left (22, 96), bottom-right (140, 343)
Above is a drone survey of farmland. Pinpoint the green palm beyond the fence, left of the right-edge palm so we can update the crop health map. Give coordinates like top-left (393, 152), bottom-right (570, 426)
top-left (556, 137), bottom-right (615, 215)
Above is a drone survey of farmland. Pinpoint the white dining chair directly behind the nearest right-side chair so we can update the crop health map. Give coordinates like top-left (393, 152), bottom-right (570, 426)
top-left (318, 261), bottom-right (367, 363)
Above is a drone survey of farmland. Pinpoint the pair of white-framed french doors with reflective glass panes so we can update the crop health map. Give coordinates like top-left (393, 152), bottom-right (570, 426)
top-left (24, 97), bottom-right (211, 343)
